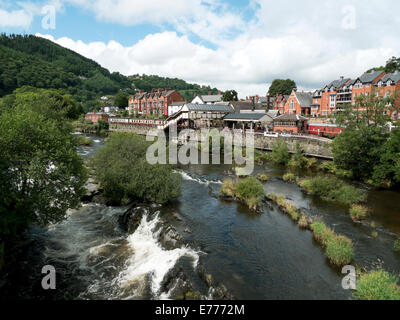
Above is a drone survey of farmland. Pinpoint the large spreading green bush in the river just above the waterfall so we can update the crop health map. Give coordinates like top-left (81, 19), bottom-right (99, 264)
top-left (90, 133), bottom-right (181, 204)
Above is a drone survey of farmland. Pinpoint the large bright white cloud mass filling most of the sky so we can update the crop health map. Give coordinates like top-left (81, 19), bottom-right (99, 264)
top-left (35, 0), bottom-right (400, 97)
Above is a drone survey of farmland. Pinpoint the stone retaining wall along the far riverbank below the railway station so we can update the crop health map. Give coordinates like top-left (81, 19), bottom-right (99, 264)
top-left (110, 124), bottom-right (333, 160)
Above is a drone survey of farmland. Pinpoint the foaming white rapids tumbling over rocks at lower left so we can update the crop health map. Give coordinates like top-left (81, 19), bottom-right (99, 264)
top-left (45, 204), bottom-right (199, 299)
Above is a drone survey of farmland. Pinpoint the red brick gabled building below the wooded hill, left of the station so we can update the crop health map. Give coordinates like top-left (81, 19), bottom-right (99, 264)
top-left (129, 89), bottom-right (185, 116)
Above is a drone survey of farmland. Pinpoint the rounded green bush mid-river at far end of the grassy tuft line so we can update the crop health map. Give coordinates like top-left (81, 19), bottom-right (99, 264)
top-left (236, 177), bottom-right (264, 210)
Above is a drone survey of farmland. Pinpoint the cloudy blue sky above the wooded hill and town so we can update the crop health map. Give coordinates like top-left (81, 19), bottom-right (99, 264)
top-left (0, 0), bottom-right (400, 98)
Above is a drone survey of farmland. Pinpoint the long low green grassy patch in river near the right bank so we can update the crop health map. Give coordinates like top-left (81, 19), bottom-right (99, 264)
top-left (298, 176), bottom-right (366, 205)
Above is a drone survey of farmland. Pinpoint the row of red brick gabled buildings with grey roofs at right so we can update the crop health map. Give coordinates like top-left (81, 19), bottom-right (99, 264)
top-left (273, 71), bottom-right (400, 119)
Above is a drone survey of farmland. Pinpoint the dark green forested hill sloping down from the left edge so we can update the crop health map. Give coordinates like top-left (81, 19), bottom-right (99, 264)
top-left (0, 34), bottom-right (222, 102)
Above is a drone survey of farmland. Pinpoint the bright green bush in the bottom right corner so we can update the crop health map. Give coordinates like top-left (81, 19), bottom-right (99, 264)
top-left (354, 270), bottom-right (400, 300)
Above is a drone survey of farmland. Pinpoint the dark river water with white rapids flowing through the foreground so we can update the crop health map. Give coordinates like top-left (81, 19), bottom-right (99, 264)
top-left (0, 137), bottom-right (400, 299)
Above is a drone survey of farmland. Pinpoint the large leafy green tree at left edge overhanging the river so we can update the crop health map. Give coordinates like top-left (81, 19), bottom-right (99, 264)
top-left (0, 104), bottom-right (86, 238)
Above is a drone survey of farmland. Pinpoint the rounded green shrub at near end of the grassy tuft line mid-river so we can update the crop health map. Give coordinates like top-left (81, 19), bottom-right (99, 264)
top-left (325, 236), bottom-right (354, 267)
